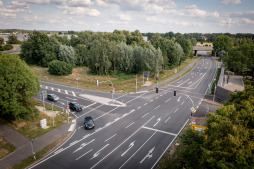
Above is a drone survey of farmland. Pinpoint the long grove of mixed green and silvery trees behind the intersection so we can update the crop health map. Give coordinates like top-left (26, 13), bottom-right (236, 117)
top-left (21, 30), bottom-right (192, 74)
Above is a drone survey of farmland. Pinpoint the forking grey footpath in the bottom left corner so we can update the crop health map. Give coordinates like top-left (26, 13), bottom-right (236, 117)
top-left (0, 122), bottom-right (74, 169)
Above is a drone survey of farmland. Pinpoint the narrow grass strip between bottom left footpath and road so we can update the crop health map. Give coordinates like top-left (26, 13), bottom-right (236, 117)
top-left (11, 134), bottom-right (69, 169)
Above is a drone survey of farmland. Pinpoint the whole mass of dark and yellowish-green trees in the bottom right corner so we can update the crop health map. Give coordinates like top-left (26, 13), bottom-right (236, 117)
top-left (164, 86), bottom-right (254, 169)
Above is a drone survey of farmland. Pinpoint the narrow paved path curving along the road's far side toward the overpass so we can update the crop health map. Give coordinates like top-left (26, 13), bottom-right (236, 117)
top-left (139, 58), bottom-right (199, 92)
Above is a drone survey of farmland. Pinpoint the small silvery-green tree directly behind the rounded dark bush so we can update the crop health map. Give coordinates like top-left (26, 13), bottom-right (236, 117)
top-left (58, 45), bottom-right (77, 65)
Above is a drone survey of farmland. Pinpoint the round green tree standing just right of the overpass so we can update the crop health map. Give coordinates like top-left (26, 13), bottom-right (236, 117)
top-left (213, 35), bottom-right (233, 53)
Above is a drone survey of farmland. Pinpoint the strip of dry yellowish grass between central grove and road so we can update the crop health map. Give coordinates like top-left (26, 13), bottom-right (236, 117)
top-left (30, 59), bottom-right (194, 93)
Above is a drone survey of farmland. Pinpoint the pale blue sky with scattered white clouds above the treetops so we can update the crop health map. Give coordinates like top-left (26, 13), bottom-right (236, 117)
top-left (0, 0), bottom-right (254, 33)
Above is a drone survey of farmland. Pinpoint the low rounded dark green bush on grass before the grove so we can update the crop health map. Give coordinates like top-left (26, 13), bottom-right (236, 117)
top-left (48, 60), bottom-right (72, 75)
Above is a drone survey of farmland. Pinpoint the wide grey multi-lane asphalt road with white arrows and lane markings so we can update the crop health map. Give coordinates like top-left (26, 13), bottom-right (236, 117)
top-left (31, 54), bottom-right (216, 169)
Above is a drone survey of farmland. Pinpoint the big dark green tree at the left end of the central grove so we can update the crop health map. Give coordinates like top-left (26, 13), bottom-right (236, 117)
top-left (21, 31), bottom-right (60, 67)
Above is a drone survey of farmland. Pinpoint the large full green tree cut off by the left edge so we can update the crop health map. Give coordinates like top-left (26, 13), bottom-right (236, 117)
top-left (0, 53), bottom-right (40, 120)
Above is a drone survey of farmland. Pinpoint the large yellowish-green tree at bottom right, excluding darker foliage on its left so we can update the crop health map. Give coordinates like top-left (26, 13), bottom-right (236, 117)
top-left (201, 86), bottom-right (254, 168)
